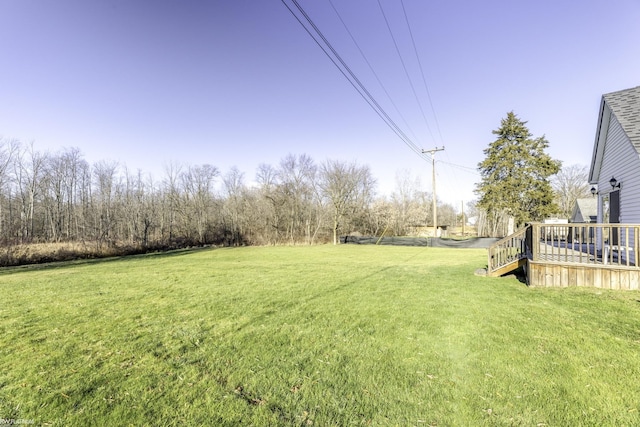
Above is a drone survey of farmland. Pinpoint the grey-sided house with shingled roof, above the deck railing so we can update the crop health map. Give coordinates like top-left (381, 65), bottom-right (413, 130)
top-left (589, 86), bottom-right (640, 229)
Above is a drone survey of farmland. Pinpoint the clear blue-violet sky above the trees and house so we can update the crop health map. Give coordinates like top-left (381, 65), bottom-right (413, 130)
top-left (0, 0), bottom-right (640, 206)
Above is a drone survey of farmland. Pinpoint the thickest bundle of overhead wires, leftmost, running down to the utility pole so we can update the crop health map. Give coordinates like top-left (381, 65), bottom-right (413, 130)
top-left (281, 0), bottom-right (422, 157)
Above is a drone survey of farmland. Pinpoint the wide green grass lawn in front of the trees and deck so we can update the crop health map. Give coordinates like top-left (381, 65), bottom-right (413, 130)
top-left (0, 245), bottom-right (640, 426)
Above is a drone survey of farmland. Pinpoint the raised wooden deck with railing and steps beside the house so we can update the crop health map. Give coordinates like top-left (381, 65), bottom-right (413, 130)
top-left (487, 223), bottom-right (640, 290)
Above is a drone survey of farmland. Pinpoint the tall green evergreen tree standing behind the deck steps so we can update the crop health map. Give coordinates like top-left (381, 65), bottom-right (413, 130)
top-left (475, 112), bottom-right (561, 229)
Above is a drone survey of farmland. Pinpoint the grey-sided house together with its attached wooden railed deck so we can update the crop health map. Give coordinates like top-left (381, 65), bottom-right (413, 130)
top-left (487, 86), bottom-right (640, 290)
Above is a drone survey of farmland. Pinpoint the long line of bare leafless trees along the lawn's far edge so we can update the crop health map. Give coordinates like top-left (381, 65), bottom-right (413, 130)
top-left (0, 138), bottom-right (464, 254)
